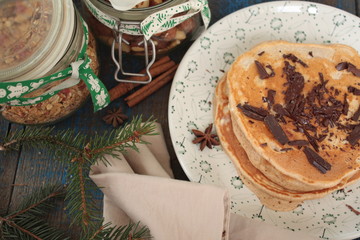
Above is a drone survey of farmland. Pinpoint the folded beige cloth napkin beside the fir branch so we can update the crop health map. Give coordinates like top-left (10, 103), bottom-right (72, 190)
top-left (90, 124), bottom-right (311, 240)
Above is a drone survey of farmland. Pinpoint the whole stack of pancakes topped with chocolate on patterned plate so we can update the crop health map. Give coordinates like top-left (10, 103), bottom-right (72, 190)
top-left (214, 41), bottom-right (360, 211)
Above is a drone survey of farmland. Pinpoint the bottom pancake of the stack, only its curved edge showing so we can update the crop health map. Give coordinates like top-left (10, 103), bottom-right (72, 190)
top-left (213, 75), bottom-right (360, 211)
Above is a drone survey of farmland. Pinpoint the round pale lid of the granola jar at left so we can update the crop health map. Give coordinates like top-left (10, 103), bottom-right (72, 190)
top-left (0, 0), bottom-right (74, 81)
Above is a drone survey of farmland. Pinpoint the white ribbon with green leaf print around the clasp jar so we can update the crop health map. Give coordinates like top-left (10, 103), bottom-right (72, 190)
top-left (85, 0), bottom-right (211, 39)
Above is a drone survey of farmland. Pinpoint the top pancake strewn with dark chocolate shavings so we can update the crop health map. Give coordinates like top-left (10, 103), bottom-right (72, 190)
top-left (226, 41), bottom-right (360, 192)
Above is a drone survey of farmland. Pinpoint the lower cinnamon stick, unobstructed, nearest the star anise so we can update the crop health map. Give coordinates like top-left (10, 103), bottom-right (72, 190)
top-left (125, 64), bottom-right (178, 107)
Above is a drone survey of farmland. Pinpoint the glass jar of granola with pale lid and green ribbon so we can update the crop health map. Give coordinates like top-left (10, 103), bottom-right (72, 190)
top-left (0, 0), bottom-right (99, 125)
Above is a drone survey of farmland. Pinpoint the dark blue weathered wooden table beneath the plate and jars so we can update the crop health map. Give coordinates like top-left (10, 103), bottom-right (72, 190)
top-left (0, 0), bottom-right (360, 239)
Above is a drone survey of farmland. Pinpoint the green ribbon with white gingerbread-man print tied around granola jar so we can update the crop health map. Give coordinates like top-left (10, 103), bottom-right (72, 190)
top-left (0, 20), bottom-right (110, 111)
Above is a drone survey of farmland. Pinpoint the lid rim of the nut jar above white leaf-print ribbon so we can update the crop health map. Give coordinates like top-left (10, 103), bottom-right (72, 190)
top-left (90, 0), bottom-right (188, 21)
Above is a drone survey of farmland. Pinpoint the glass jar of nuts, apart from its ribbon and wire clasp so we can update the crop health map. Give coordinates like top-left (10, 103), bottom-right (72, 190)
top-left (81, 0), bottom-right (200, 55)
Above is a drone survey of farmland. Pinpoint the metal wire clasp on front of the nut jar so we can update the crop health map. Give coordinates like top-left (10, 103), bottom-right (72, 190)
top-left (111, 21), bottom-right (156, 84)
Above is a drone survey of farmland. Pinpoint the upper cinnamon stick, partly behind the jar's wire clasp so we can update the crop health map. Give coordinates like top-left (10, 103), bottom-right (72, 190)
top-left (109, 56), bottom-right (175, 101)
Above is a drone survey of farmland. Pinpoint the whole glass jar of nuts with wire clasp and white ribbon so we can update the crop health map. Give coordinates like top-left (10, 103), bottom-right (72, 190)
top-left (83, 0), bottom-right (210, 84)
